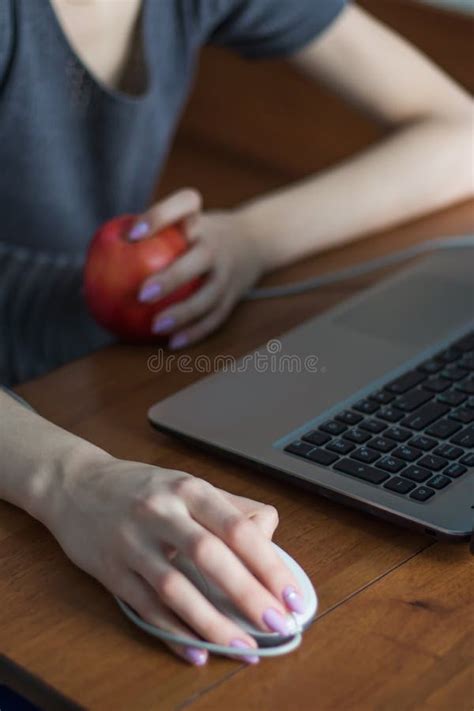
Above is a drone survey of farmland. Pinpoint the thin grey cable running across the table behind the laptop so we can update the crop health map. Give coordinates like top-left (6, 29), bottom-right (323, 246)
top-left (244, 235), bottom-right (474, 301)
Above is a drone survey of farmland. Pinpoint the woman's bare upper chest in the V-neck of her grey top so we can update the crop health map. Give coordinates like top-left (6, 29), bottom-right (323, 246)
top-left (50, 0), bottom-right (142, 89)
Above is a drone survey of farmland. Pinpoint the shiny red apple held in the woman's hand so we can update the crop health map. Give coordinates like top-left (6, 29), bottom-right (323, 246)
top-left (84, 215), bottom-right (202, 343)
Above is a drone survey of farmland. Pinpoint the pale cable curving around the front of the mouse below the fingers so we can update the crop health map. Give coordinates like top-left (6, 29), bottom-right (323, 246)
top-left (115, 596), bottom-right (303, 657)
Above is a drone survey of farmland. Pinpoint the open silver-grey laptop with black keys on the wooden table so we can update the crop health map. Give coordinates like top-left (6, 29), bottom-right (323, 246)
top-left (149, 248), bottom-right (474, 540)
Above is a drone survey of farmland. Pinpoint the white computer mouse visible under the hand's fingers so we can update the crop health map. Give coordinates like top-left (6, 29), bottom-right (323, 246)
top-left (173, 543), bottom-right (318, 647)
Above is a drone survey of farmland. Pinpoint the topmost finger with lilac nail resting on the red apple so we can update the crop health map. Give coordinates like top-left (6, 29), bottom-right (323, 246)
top-left (128, 188), bottom-right (202, 242)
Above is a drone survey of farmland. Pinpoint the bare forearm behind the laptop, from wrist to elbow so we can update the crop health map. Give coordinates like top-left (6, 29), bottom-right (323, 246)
top-left (237, 119), bottom-right (473, 270)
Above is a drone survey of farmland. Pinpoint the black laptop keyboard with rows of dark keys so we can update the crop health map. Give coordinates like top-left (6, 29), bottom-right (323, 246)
top-left (285, 331), bottom-right (474, 502)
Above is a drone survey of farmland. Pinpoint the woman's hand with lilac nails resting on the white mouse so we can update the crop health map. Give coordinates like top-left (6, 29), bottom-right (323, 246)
top-left (46, 453), bottom-right (303, 665)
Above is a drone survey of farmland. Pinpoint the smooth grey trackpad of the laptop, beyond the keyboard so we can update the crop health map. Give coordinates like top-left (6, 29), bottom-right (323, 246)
top-left (334, 274), bottom-right (474, 345)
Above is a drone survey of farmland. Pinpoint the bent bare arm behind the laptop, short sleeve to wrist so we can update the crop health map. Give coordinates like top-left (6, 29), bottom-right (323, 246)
top-left (235, 7), bottom-right (474, 268)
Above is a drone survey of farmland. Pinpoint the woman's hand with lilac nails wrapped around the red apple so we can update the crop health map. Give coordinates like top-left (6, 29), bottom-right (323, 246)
top-left (130, 189), bottom-right (264, 349)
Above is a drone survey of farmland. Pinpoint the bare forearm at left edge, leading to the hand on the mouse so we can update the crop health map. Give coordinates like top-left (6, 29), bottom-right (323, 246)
top-left (0, 392), bottom-right (108, 525)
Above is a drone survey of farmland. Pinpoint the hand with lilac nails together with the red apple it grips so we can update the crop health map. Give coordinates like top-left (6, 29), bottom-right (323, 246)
top-left (85, 189), bottom-right (264, 349)
